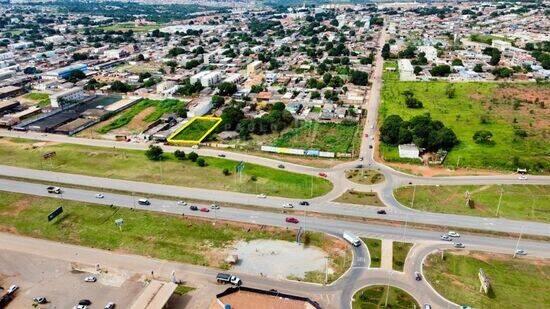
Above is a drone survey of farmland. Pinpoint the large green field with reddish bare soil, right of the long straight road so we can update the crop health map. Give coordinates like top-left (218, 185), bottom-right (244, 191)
top-left (380, 62), bottom-right (550, 173)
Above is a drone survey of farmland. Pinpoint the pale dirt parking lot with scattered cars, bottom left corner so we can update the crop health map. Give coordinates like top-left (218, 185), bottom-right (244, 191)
top-left (0, 250), bottom-right (143, 309)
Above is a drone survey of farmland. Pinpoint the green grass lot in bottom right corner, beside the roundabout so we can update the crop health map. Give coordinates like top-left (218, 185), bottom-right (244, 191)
top-left (424, 251), bottom-right (550, 309)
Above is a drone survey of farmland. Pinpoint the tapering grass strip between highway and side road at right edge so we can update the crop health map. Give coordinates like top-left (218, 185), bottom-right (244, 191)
top-left (394, 185), bottom-right (550, 223)
